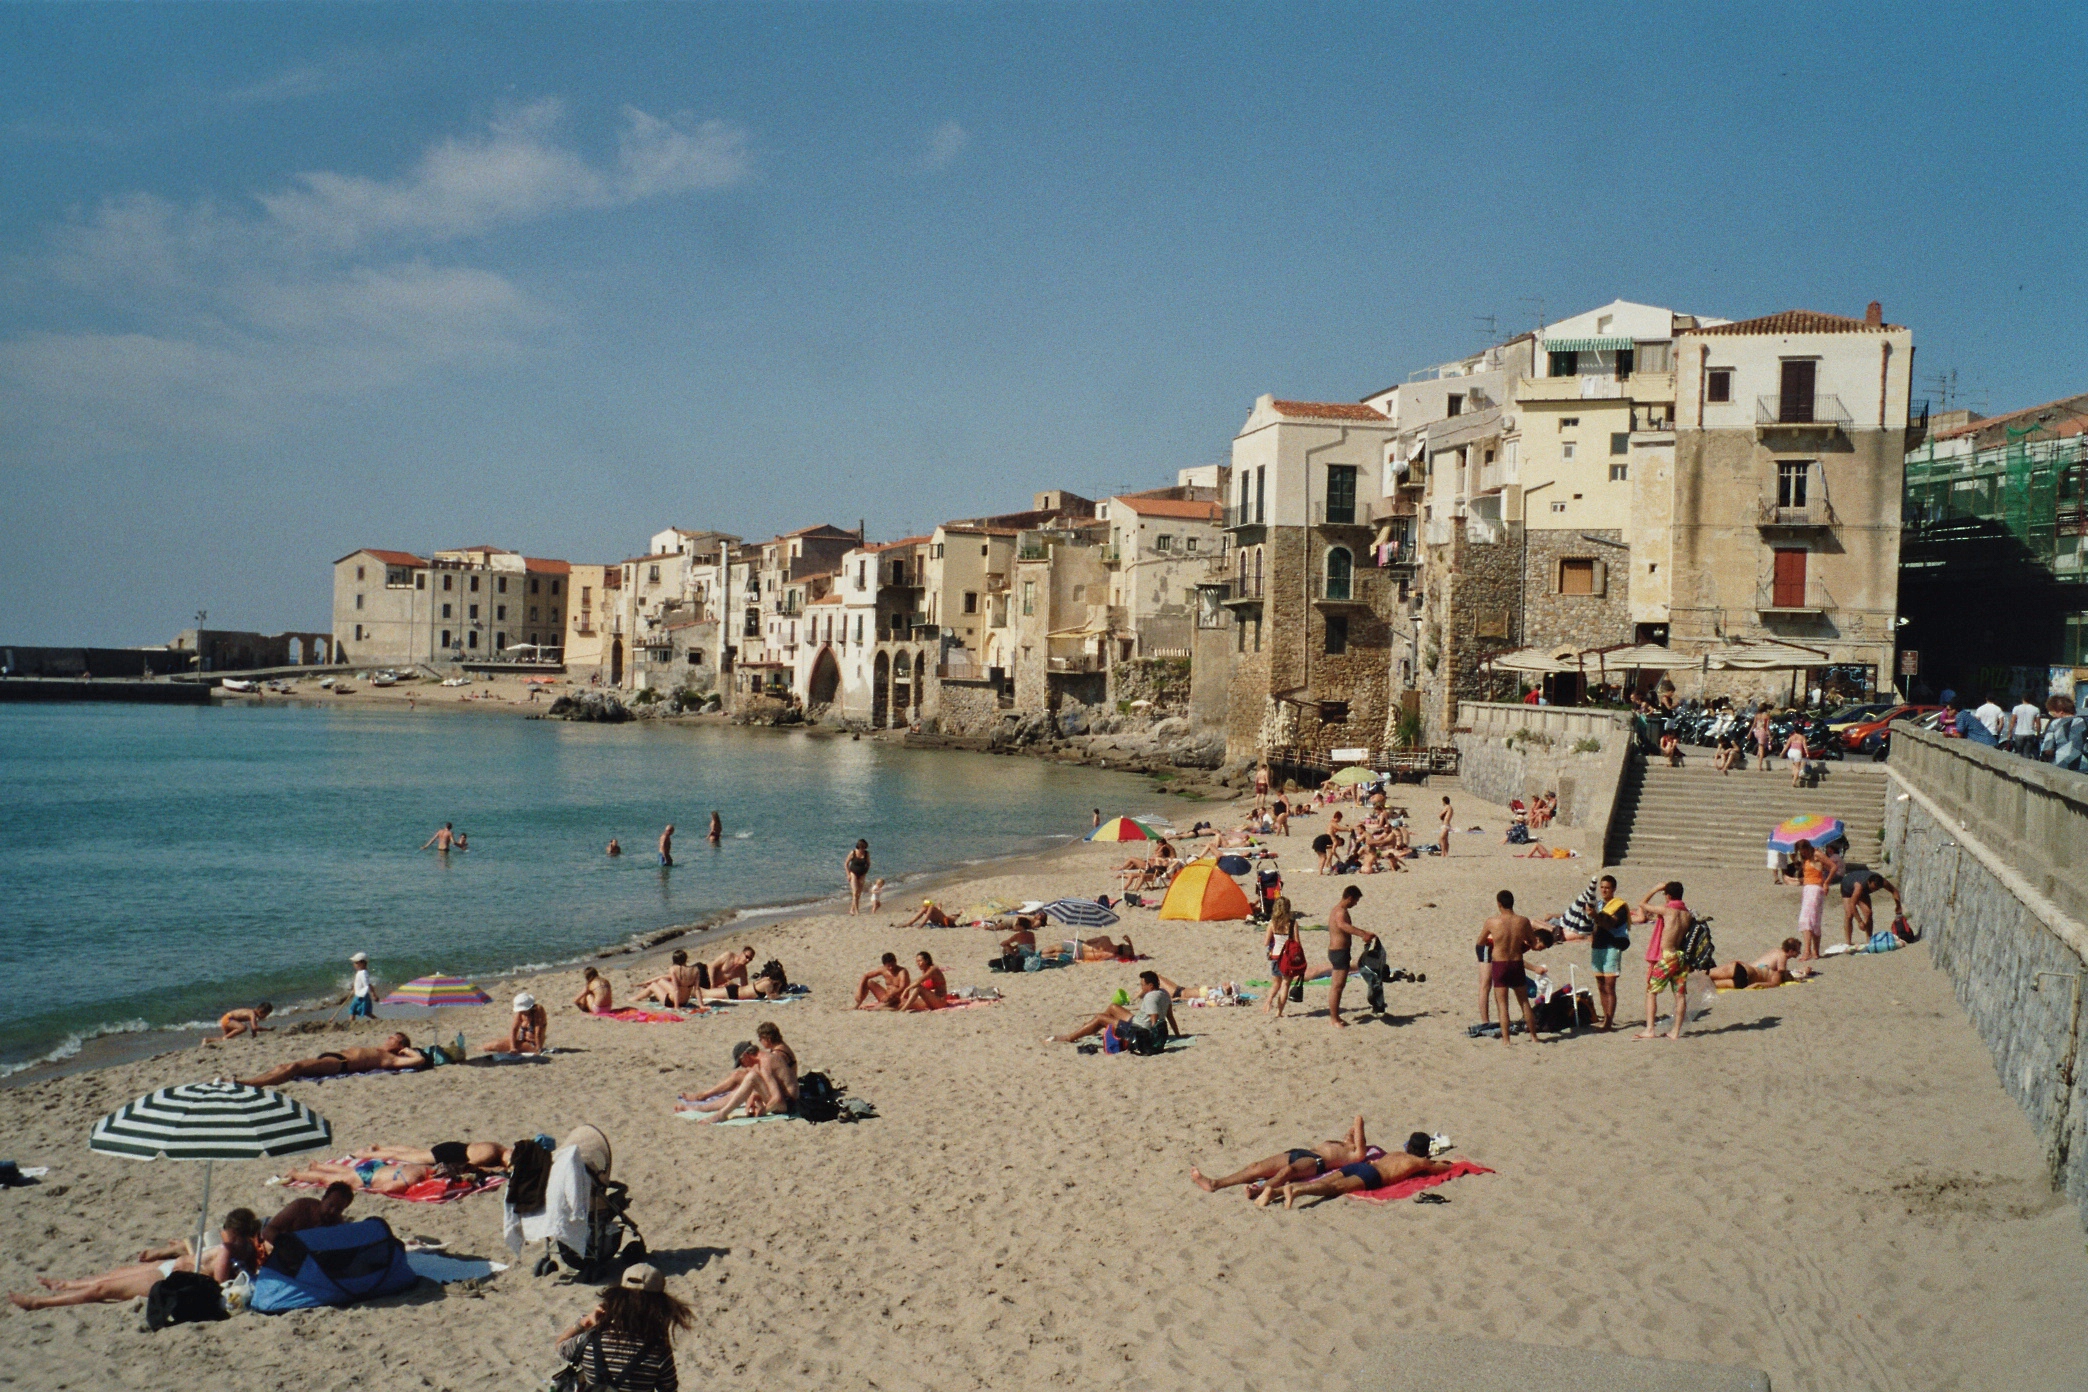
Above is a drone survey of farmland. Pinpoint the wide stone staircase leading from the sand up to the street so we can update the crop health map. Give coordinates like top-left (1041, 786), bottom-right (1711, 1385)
top-left (1606, 749), bottom-right (1888, 870)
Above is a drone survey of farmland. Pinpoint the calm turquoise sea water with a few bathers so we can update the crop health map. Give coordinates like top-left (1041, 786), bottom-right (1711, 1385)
top-left (0, 705), bottom-right (1150, 1064)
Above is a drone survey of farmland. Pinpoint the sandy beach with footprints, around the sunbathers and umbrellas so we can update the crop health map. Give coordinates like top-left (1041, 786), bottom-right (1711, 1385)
top-left (0, 789), bottom-right (2088, 1392)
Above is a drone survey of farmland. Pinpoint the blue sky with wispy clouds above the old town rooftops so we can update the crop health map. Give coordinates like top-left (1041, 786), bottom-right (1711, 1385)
top-left (0, 2), bottom-right (2088, 645)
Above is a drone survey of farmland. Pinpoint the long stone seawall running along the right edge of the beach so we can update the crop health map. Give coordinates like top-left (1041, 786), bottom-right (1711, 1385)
top-left (1885, 728), bottom-right (2088, 1223)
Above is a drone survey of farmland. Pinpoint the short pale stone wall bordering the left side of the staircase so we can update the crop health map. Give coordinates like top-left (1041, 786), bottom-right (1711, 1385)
top-left (1455, 701), bottom-right (1631, 856)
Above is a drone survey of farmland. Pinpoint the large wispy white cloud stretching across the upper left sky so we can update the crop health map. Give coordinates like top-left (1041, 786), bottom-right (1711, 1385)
top-left (0, 102), bottom-right (750, 453)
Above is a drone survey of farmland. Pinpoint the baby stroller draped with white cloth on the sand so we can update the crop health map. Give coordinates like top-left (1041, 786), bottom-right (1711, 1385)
top-left (505, 1125), bottom-right (645, 1286)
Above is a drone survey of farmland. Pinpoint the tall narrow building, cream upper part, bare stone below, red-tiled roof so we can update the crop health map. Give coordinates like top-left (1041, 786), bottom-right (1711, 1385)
top-left (1226, 394), bottom-right (1399, 760)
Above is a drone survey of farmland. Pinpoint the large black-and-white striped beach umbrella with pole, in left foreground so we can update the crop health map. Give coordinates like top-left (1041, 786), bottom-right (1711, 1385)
top-left (88, 1079), bottom-right (334, 1256)
